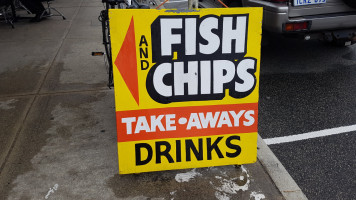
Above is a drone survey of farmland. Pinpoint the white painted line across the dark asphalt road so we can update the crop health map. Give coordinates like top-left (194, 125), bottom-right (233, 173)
top-left (263, 125), bottom-right (356, 145)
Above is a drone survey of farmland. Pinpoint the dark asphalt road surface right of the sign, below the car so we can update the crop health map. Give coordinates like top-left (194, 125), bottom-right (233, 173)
top-left (259, 34), bottom-right (356, 200)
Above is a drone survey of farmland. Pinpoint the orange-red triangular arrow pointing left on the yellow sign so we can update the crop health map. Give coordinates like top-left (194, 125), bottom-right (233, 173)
top-left (115, 17), bottom-right (139, 105)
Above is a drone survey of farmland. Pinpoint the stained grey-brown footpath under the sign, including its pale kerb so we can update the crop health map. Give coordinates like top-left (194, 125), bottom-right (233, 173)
top-left (0, 0), bottom-right (304, 200)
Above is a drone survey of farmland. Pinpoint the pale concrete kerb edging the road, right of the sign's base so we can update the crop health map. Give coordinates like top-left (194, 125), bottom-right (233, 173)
top-left (257, 135), bottom-right (308, 200)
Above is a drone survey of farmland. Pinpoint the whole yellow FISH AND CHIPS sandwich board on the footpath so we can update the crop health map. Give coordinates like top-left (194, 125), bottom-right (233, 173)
top-left (109, 8), bottom-right (262, 174)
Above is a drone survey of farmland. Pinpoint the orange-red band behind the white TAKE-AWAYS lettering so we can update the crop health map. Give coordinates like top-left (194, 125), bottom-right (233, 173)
top-left (116, 103), bottom-right (258, 142)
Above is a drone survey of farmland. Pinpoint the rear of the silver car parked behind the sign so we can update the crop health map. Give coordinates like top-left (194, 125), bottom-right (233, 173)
top-left (201, 0), bottom-right (356, 45)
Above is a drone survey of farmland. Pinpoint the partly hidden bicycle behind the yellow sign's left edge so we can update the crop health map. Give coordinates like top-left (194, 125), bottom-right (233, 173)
top-left (92, 0), bottom-right (150, 88)
